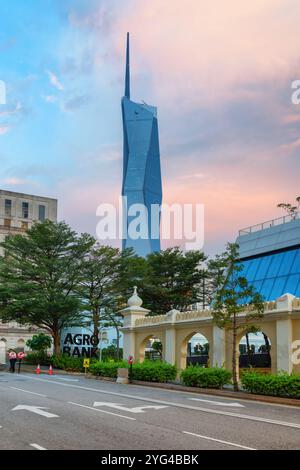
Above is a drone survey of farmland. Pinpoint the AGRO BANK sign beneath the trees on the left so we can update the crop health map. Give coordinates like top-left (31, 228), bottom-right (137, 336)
top-left (63, 333), bottom-right (99, 357)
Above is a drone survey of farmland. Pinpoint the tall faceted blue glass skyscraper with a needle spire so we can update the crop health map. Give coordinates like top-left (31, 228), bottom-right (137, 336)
top-left (122, 33), bottom-right (162, 256)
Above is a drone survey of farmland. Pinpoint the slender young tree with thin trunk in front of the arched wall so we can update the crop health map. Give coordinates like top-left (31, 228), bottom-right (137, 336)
top-left (212, 243), bottom-right (264, 391)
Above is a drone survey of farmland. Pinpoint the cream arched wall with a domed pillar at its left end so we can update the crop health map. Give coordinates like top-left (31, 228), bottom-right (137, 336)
top-left (121, 288), bottom-right (300, 373)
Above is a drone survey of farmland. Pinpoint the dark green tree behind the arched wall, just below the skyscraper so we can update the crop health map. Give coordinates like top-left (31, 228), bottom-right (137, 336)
top-left (136, 247), bottom-right (206, 315)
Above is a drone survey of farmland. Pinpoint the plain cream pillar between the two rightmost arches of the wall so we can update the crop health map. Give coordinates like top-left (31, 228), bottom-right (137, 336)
top-left (276, 318), bottom-right (293, 374)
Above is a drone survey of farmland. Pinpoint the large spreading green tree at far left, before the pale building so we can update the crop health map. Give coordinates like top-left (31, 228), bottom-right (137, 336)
top-left (0, 220), bottom-right (95, 354)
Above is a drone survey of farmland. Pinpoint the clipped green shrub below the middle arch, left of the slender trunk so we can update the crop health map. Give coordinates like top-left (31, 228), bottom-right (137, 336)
top-left (180, 366), bottom-right (231, 388)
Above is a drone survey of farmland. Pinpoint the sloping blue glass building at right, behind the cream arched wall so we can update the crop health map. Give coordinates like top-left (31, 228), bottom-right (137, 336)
top-left (237, 213), bottom-right (300, 300)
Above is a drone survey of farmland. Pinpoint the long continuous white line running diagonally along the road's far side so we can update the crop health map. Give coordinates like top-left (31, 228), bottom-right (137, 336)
top-left (17, 376), bottom-right (300, 429)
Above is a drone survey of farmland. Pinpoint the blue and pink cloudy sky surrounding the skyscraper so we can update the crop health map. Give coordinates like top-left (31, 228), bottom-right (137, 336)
top-left (0, 0), bottom-right (300, 254)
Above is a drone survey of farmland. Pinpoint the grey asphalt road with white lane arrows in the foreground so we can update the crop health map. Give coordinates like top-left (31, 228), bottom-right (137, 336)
top-left (0, 372), bottom-right (300, 450)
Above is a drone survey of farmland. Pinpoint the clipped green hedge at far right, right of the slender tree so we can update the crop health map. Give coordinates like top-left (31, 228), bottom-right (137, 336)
top-left (241, 371), bottom-right (300, 398)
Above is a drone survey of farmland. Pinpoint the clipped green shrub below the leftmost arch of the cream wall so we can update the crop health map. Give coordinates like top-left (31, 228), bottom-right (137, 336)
top-left (132, 361), bottom-right (177, 383)
